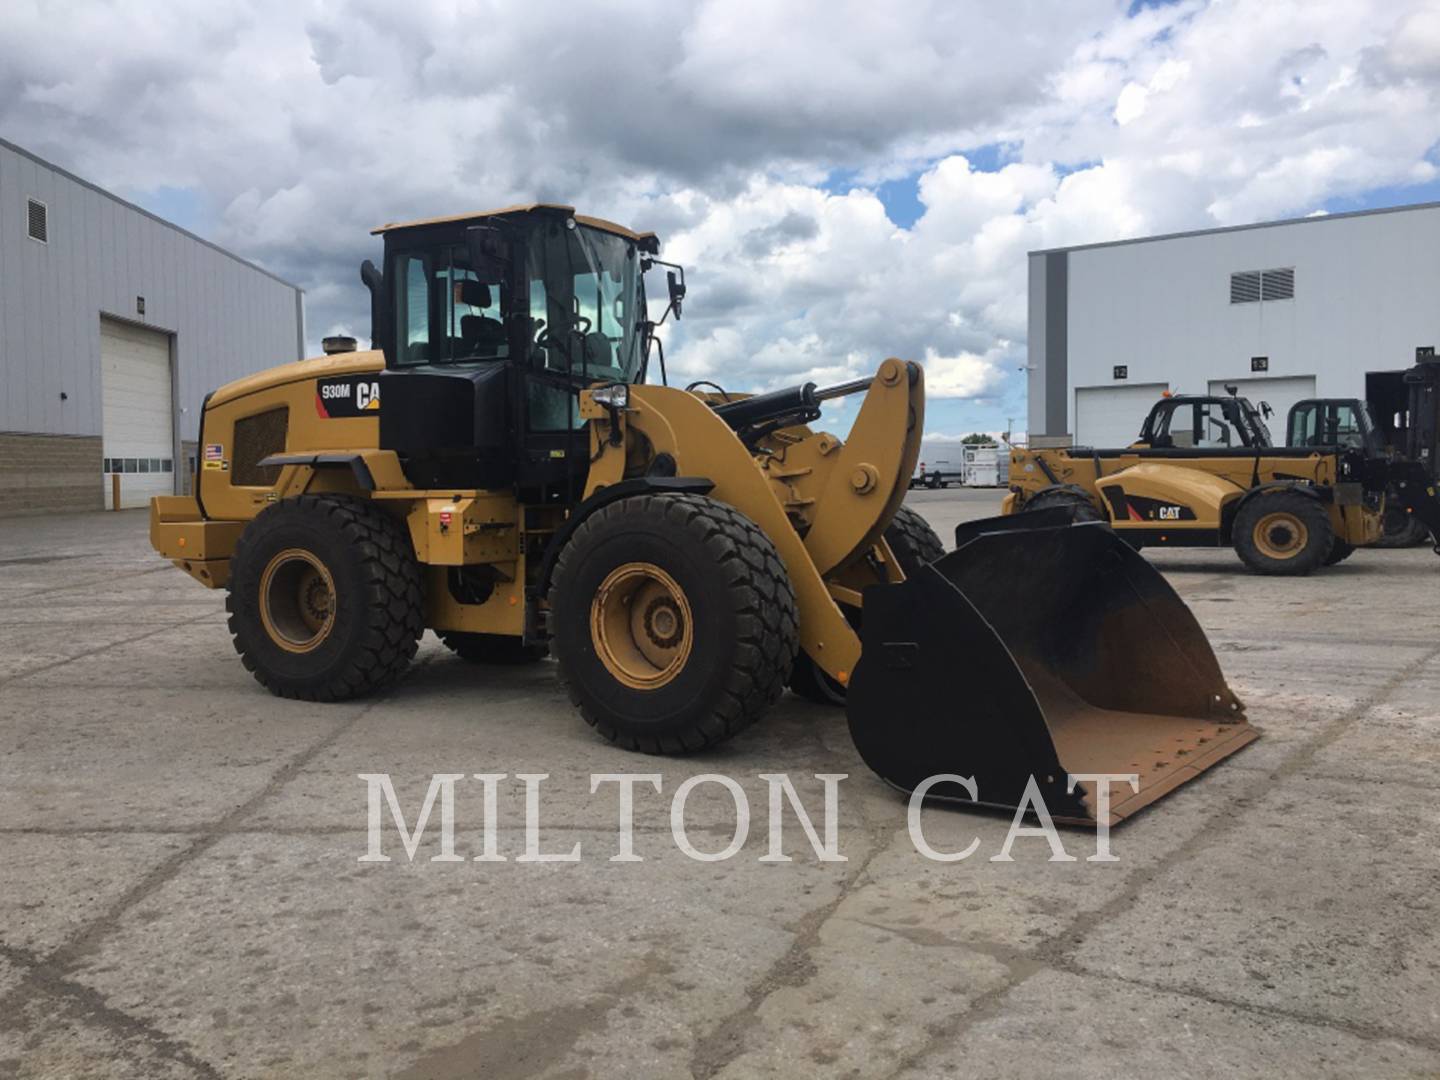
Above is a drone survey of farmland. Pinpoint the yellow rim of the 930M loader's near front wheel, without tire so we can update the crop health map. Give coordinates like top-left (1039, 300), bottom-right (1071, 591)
top-left (590, 563), bottom-right (694, 690)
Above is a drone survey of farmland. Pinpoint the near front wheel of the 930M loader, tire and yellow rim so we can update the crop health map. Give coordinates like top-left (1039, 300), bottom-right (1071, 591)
top-left (550, 494), bottom-right (799, 753)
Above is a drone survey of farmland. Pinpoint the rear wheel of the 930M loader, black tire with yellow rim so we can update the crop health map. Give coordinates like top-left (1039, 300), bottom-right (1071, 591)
top-left (225, 495), bottom-right (425, 701)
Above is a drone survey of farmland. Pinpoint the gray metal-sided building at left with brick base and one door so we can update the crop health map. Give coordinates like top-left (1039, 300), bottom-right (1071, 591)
top-left (0, 140), bottom-right (305, 514)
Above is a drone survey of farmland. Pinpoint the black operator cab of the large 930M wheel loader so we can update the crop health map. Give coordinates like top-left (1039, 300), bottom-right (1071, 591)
top-left (361, 204), bottom-right (660, 503)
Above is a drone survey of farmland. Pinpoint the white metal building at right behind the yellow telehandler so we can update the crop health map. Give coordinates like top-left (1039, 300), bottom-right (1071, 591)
top-left (1028, 203), bottom-right (1440, 446)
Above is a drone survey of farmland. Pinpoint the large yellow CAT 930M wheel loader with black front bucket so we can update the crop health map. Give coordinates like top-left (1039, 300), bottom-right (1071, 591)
top-left (151, 204), bottom-right (1256, 824)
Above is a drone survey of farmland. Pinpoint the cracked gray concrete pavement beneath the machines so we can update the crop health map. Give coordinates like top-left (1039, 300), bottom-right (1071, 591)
top-left (0, 490), bottom-right (1440, 1079)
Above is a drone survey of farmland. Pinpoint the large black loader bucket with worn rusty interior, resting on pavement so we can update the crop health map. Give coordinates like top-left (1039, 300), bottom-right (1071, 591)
top-left (847, 510), bottom-right (1260, 827)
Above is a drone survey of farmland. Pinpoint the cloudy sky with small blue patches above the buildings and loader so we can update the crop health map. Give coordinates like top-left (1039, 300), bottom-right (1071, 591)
top-left (0, 0), bottom-right (1440, 435)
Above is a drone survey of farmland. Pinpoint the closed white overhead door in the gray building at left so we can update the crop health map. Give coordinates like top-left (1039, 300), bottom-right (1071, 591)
top-left (99, 318), bottom-right (174, 507)
